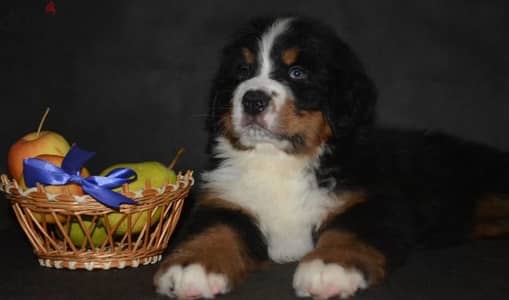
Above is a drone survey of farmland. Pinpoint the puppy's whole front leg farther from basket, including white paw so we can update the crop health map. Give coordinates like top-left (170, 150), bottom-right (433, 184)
top-left (293, 196), bottom-right (406, 299)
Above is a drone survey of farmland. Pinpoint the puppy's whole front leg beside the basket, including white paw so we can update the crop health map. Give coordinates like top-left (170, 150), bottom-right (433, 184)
top-left (154, 201), bottom-right (268, 298)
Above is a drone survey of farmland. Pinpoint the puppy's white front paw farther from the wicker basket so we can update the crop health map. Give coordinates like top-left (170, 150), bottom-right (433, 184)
top-left (293, 259), bottom-right (367, 299)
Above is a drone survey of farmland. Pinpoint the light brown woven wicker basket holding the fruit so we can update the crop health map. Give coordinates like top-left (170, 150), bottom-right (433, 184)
top-left (0, 171), bottom-right (194, 270)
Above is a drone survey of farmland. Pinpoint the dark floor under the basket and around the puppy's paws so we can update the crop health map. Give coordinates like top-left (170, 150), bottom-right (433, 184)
top-left (0, 227), bottom-right (509, 300)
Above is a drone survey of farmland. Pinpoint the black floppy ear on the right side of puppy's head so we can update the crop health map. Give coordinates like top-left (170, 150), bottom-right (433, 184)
top-left (325, 67), bottom-right (377, 138)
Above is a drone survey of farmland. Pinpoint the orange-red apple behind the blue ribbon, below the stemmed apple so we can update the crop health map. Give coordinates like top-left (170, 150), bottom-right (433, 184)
top-left (19, 154), bottom-right (90, 224)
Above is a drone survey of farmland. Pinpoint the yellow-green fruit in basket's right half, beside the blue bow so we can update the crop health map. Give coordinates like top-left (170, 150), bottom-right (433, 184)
top-left (100, 161), bottom-right (177, 235)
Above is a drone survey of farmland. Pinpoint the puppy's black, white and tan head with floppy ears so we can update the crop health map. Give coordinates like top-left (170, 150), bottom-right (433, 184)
top-left (209, 18), bottom-right (376, 154)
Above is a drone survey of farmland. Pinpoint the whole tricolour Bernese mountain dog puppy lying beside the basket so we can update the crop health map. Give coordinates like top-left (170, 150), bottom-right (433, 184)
top-left (154, 18), bottom-right (509, 299)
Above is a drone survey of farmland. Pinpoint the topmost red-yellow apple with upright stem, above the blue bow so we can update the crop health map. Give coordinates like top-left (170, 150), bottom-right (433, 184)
top-left (7, 109), bottom-right (71, 182)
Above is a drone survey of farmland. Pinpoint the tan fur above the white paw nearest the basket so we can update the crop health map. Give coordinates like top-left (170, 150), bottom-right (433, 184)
top-left (155, 225), bottom-right (261, 287)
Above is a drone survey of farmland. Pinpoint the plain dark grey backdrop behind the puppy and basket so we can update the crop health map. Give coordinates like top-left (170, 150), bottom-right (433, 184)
top-left (0, 0), bottom-right (509, 299)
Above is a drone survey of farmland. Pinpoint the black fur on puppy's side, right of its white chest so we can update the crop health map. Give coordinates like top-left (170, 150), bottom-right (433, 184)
top-left (317, 129), bottom-right (509, 266)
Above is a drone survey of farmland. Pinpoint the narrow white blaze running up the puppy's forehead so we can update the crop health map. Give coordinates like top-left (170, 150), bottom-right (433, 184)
top-left (258, 18), bottom-right (291, 77)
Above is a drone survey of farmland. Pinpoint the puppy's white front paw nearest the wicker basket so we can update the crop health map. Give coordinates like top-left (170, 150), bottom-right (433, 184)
top-left (155, 264), bottom-right (229, 299)
